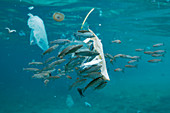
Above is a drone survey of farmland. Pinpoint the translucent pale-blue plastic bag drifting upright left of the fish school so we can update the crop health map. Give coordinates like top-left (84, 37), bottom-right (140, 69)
top-left (28, 13), bottom-right (49, 51)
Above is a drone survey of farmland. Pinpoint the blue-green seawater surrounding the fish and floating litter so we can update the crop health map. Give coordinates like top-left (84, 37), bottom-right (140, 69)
top-left (0, 0), bottom-right (170, 113)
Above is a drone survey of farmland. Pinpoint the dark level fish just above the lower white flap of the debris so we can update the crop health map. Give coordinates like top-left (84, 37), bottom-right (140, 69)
top-left (75, 50), bottom-right (99, 56)
